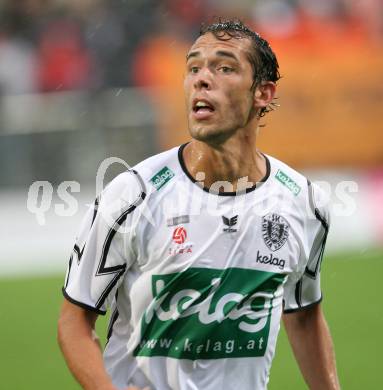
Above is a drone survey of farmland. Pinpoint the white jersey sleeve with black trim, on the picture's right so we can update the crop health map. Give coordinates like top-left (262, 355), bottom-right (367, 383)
top-left (284, 182), bottom-right (330, 313)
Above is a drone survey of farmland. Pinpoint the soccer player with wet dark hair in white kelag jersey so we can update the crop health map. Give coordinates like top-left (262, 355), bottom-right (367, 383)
top-left (58, 20), bottom-right (339, 390)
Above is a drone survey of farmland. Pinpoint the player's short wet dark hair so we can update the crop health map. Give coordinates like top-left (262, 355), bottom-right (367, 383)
top-left (199, 18), bottom-right (281, 117)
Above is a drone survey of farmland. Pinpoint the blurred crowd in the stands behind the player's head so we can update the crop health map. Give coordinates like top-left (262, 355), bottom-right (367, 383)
top-left (0, 0), bottom-right (383, 95)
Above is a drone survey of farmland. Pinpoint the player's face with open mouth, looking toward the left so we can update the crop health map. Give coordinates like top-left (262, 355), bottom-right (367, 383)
top-left (184, 33), bottom-right (255, 142)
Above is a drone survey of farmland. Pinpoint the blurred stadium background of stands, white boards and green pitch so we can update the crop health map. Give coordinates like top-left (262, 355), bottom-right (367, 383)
top-left (0, 0), bottom-right (383, 390)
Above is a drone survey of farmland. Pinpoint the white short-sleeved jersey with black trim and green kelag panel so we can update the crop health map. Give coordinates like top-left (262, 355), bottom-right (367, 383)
top-left (63, 145), bottom-right (328, 390)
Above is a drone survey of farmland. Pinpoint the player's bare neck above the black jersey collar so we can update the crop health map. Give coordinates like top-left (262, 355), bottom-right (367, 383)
top-left (183, 132), bottom-right (267, 191)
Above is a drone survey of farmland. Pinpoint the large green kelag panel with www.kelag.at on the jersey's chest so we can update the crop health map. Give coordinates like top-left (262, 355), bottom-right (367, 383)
top-left (134, 268), bottom-right (285, 360)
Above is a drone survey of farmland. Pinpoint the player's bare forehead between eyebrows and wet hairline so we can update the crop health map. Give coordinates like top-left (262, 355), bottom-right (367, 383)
top-left (189, 33), bottom-right (251, 54)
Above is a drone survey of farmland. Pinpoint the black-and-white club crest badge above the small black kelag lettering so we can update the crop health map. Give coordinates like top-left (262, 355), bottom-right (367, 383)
top-left (262, 213), bottom-right (290, 251)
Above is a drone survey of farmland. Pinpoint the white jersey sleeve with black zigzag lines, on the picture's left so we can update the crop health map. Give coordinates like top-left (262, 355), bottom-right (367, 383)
top-left (63, 171), bottom-right (145, 314)
